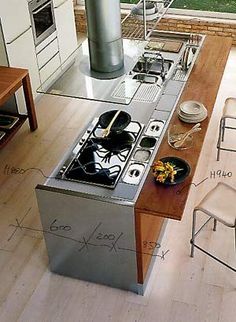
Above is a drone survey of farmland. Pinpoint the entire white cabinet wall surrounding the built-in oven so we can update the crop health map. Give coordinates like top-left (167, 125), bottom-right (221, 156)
top-left (0, 0), bottom-right (77, 113)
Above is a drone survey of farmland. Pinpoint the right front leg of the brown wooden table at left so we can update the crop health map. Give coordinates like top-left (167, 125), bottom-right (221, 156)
top-left (22, 74), bottom-right (38, 131)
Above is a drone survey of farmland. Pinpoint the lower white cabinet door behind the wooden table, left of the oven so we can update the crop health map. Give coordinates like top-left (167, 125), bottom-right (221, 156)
top-left (6, 28), bottom-right (40, 112)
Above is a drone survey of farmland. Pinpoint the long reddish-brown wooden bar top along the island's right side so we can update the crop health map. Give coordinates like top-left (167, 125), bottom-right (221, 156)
top-left (135, 36), bottom-right (232, 220)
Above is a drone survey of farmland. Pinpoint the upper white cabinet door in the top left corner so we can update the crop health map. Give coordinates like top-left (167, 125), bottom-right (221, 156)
top-left (0, 0), bottom-right (31, 43)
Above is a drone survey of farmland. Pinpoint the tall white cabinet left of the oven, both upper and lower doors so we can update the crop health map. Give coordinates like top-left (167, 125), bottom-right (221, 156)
top-left (0, 0), bottom-right (40, 113)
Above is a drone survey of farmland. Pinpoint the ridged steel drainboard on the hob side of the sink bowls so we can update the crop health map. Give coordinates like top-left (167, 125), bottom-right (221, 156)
top-left (133, 84), bottom-right (160, 103)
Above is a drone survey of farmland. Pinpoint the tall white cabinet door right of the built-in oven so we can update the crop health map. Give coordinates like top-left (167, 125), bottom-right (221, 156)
top-left (54, 0), bottom-right (78, 64)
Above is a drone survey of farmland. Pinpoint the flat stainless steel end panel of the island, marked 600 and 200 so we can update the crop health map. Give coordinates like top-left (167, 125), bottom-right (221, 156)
top-left (36, 186), bottom-right (138, 292)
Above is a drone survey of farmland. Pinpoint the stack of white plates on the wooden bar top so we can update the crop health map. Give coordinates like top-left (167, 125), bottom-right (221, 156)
top-left (178, 101), bottom-right (207, 123)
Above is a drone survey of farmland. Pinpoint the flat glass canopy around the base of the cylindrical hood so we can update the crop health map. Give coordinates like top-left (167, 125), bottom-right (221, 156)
top-left (40, 39), bottom-right (147, 105)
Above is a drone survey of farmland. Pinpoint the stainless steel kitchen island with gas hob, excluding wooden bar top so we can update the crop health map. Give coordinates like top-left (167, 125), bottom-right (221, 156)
top-left (36, 35), bottom-right (203, 294)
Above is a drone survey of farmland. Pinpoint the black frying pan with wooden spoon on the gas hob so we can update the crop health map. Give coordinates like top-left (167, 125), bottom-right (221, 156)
top-left (98, 110), bottom-right (131, 133)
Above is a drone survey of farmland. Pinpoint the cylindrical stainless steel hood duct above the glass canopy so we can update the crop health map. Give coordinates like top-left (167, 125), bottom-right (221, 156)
top-left (85, 0), bottom-right (124, 73)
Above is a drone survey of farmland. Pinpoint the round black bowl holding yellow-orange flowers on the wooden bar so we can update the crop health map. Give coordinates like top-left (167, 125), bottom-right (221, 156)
top-left (155, 157), bottom-right (190, 186)
